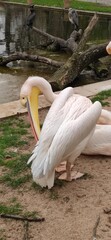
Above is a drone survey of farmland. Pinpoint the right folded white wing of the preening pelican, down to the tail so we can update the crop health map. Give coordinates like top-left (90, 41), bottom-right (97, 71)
top-left (32, 102), bottom-right (101, 187)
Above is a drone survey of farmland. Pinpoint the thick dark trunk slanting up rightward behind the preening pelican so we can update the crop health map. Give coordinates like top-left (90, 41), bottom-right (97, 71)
top-left (50, 43), bottom-right (108, 89)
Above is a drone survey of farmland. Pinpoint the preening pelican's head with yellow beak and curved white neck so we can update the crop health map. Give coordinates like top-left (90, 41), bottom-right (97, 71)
top-left (20, 76), bottom-right (57, 141)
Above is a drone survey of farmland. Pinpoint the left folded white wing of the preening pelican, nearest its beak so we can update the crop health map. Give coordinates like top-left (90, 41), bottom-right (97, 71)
top-left (28, 87), bottom-right (73, 163)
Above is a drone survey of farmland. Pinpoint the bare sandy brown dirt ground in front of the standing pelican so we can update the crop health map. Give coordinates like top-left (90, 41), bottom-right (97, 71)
top-left (0, 103), bottom-right (111, 240)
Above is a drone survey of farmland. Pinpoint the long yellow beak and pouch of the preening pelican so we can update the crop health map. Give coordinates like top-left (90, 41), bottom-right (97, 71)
top-left (27, 87), bottom-right (40, 141)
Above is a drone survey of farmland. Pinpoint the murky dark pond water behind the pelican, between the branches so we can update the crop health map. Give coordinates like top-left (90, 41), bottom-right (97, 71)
top-left (0, 2), bottom-right (111, 103)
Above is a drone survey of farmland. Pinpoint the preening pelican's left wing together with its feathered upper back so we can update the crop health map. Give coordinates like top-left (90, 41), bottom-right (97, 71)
top-left (28, 88), bottom-right (92, 163)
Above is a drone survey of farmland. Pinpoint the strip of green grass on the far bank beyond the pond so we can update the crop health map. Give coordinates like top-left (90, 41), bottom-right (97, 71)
top-left (5, 0), bottom-right (111, 13)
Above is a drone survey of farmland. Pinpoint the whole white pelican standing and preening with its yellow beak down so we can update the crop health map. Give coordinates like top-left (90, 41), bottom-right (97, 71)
top-left (20, 77), bottom-right (101, 188)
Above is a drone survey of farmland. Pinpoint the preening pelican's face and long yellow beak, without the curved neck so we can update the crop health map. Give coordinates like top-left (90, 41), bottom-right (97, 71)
top-left (20, 77), bottom-right (41, 141)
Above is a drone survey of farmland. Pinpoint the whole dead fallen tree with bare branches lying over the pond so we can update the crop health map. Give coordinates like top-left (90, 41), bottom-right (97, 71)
top-left (0, 14), bottom-right (108, 89)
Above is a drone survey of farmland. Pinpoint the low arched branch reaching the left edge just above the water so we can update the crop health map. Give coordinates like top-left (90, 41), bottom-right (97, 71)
top-left (0, 52), bottom-right (63, 68)
